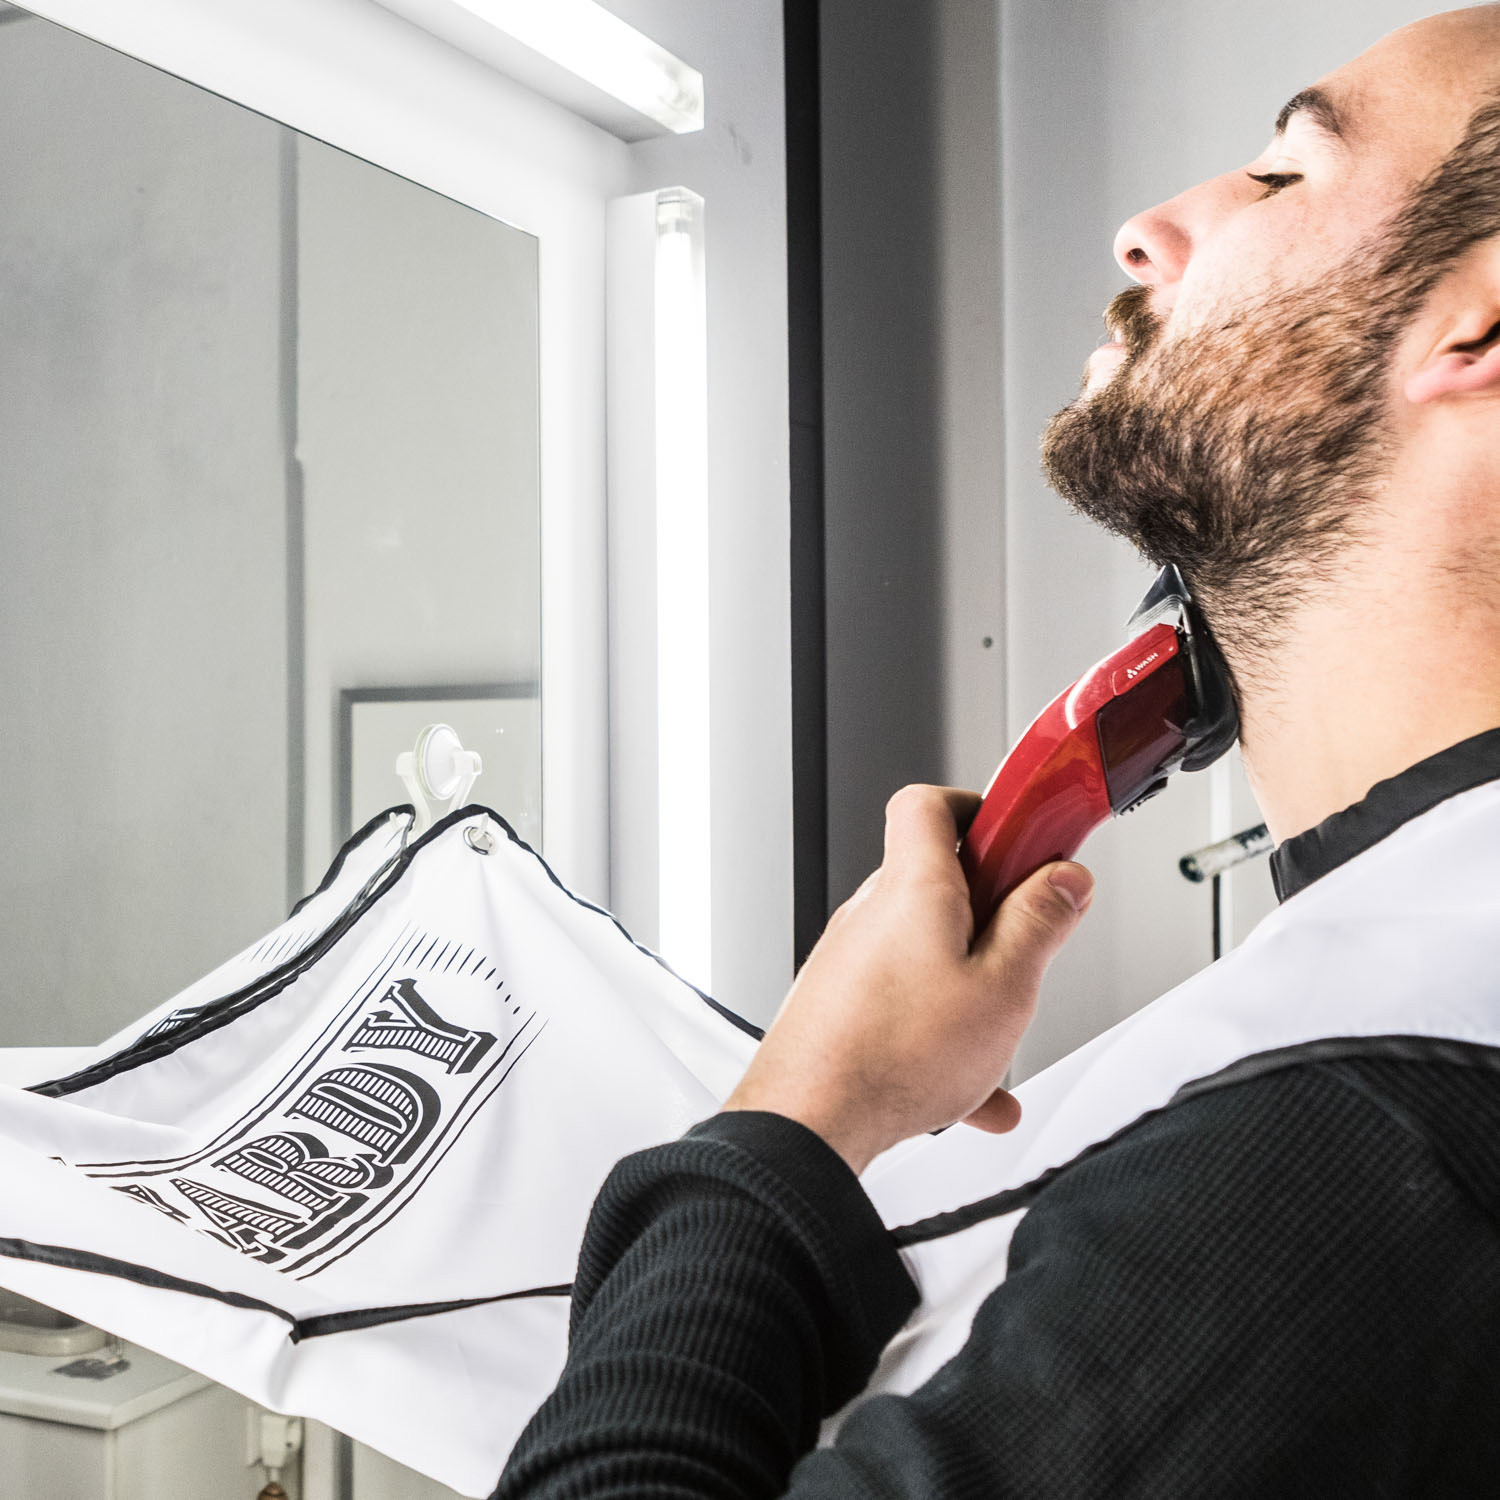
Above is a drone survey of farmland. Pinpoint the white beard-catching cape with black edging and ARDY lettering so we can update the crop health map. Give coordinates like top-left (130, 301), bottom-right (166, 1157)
top-left (0, 783), bottom-right (1500, 1496)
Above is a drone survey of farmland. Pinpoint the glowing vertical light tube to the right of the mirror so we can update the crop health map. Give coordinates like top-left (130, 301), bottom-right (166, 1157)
top-left (654, 189), bottom-right (713, 990)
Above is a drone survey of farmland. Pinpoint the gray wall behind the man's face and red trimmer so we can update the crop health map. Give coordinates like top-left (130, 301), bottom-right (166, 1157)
top-left (821, 0), bottom-right (1446, 1077)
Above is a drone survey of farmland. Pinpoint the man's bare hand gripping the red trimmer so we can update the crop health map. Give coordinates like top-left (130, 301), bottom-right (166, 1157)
top-left (725, 786), bottom-right (1094, 1172)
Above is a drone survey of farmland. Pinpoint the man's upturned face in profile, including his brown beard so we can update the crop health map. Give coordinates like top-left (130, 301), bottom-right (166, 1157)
top-left (1044, 6), bottom-right (1500, 675)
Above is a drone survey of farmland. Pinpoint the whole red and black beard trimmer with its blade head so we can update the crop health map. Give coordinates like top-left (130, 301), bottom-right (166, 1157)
top-left (959, 566), bottom-right (1239, 933)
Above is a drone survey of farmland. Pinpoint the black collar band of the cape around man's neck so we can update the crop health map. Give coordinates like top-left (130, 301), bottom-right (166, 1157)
top-left (1271, 729), bottom-right (1500, 902)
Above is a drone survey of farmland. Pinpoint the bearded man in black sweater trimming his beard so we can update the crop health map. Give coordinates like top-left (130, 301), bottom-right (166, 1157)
top-left (498, 6), bottom-right (1500, 1500)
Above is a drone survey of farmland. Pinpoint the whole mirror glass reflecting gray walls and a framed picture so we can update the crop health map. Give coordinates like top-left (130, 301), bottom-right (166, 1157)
top-left (0, 6), bottom-right (540, 1046)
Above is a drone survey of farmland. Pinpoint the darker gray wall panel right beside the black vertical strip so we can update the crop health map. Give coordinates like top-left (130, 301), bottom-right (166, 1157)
top-left (821, 0), bottom-right (1005, 903)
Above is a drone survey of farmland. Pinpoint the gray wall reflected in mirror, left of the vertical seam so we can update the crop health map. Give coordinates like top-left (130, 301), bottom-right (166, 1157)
top-left (0, 21), bottom-right (287, 1046)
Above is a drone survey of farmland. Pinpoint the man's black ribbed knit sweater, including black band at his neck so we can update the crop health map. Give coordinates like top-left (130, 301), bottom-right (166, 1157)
top-left (497, 734), bottom-right (1500, 1500)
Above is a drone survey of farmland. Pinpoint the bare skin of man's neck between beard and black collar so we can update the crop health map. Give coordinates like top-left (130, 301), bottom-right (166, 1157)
top-left (1232, 555), bottom-right (1500, 843)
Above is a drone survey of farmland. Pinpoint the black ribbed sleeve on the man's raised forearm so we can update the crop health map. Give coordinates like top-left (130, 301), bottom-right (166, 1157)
top-left (498, 1113), bottom-right (917, 1500)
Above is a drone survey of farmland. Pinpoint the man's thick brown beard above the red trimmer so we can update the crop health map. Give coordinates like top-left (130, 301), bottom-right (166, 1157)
top-left (1043, 264), bottom-right (1400, 678)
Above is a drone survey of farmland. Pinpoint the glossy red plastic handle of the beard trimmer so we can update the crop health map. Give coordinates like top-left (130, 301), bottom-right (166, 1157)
top-left (959, 624), bottom-right (1181, 933)
